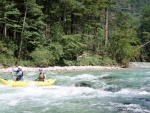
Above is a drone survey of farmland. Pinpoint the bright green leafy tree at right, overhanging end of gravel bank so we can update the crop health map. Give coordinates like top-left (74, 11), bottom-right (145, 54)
top-left (109, 12), bottom-right (139, 66)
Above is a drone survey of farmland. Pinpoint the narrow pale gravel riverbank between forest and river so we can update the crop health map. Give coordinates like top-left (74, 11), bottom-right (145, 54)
top-left (0, 66), bottom-right (122, 73)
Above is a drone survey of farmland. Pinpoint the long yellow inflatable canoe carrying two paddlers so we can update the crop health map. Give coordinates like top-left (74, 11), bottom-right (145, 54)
top-left (0, 78), bottom-right (56, 87)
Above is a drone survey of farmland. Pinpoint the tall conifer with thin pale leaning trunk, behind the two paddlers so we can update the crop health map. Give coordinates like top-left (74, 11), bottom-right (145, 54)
top-left (15, 0), bottom-right (45, 60)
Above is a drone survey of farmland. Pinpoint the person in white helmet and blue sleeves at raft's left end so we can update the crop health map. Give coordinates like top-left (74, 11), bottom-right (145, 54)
top-left (13, 66), bottom-right (23, 81)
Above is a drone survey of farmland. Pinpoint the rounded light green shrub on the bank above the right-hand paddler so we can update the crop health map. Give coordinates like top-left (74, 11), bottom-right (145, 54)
top-left (31, 44), bottom-right (63, 66)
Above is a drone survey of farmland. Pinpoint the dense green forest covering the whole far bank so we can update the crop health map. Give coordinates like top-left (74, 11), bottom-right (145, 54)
top-left (0, 0), bottom-right (150, 67)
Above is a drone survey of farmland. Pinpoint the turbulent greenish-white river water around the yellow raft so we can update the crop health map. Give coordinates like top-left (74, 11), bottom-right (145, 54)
top-left (0, 69), bottom-right (150, 113)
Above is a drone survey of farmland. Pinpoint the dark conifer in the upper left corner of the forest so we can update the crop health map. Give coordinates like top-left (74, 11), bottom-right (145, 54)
top-left (0, 1), bottom-right (21, 39)
